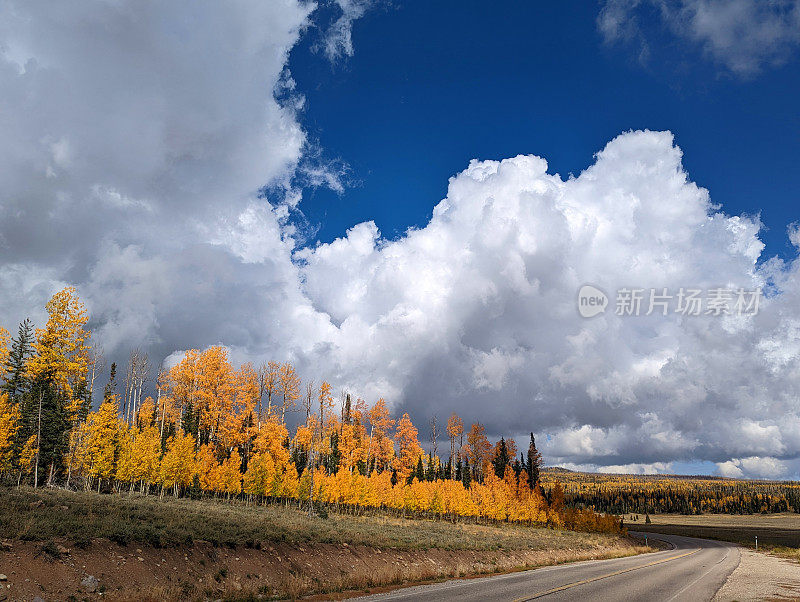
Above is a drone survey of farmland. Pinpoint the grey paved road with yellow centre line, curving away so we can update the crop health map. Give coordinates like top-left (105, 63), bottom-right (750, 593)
top-left (360, 533), bottom-right (739, 602)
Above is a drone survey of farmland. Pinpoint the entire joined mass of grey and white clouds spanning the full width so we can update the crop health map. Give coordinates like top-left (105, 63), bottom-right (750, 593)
top-left (0, 0), bottom-right (800, 476)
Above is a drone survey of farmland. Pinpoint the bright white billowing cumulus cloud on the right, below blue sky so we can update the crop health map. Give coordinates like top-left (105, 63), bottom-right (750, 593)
top-left (296, 132), bottom-right (800, 475)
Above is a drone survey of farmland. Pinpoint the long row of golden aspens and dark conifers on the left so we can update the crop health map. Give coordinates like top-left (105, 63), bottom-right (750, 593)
top-left (0, 288), bottom-right (621, 532)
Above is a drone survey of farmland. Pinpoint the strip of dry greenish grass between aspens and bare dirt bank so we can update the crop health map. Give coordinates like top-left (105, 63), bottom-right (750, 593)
top-left (0, 488), bottom-right (616, 550)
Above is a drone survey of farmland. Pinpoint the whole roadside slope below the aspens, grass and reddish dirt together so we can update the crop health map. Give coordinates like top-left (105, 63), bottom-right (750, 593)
top-left (0, 488), bottom-right (647, 602)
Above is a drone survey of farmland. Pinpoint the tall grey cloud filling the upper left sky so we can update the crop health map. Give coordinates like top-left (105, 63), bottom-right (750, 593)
top-left (0, 0), bottom-right (326, 353)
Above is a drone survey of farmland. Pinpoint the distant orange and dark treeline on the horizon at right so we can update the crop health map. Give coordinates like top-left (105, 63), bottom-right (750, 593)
top-left (542, 471), bottom-right (800, 514)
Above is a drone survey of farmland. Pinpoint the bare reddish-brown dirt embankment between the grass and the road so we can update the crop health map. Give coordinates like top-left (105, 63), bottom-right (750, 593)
top-left (0, 539), bottom-right (641, 602)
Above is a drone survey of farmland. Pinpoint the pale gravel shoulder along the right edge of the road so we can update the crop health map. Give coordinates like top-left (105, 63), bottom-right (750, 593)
top-left (714, 548), bottom-right (800, 602)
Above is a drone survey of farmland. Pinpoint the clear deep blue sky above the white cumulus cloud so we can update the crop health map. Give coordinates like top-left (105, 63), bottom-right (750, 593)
top-left (289, 1), bottom-right (800, 257)
